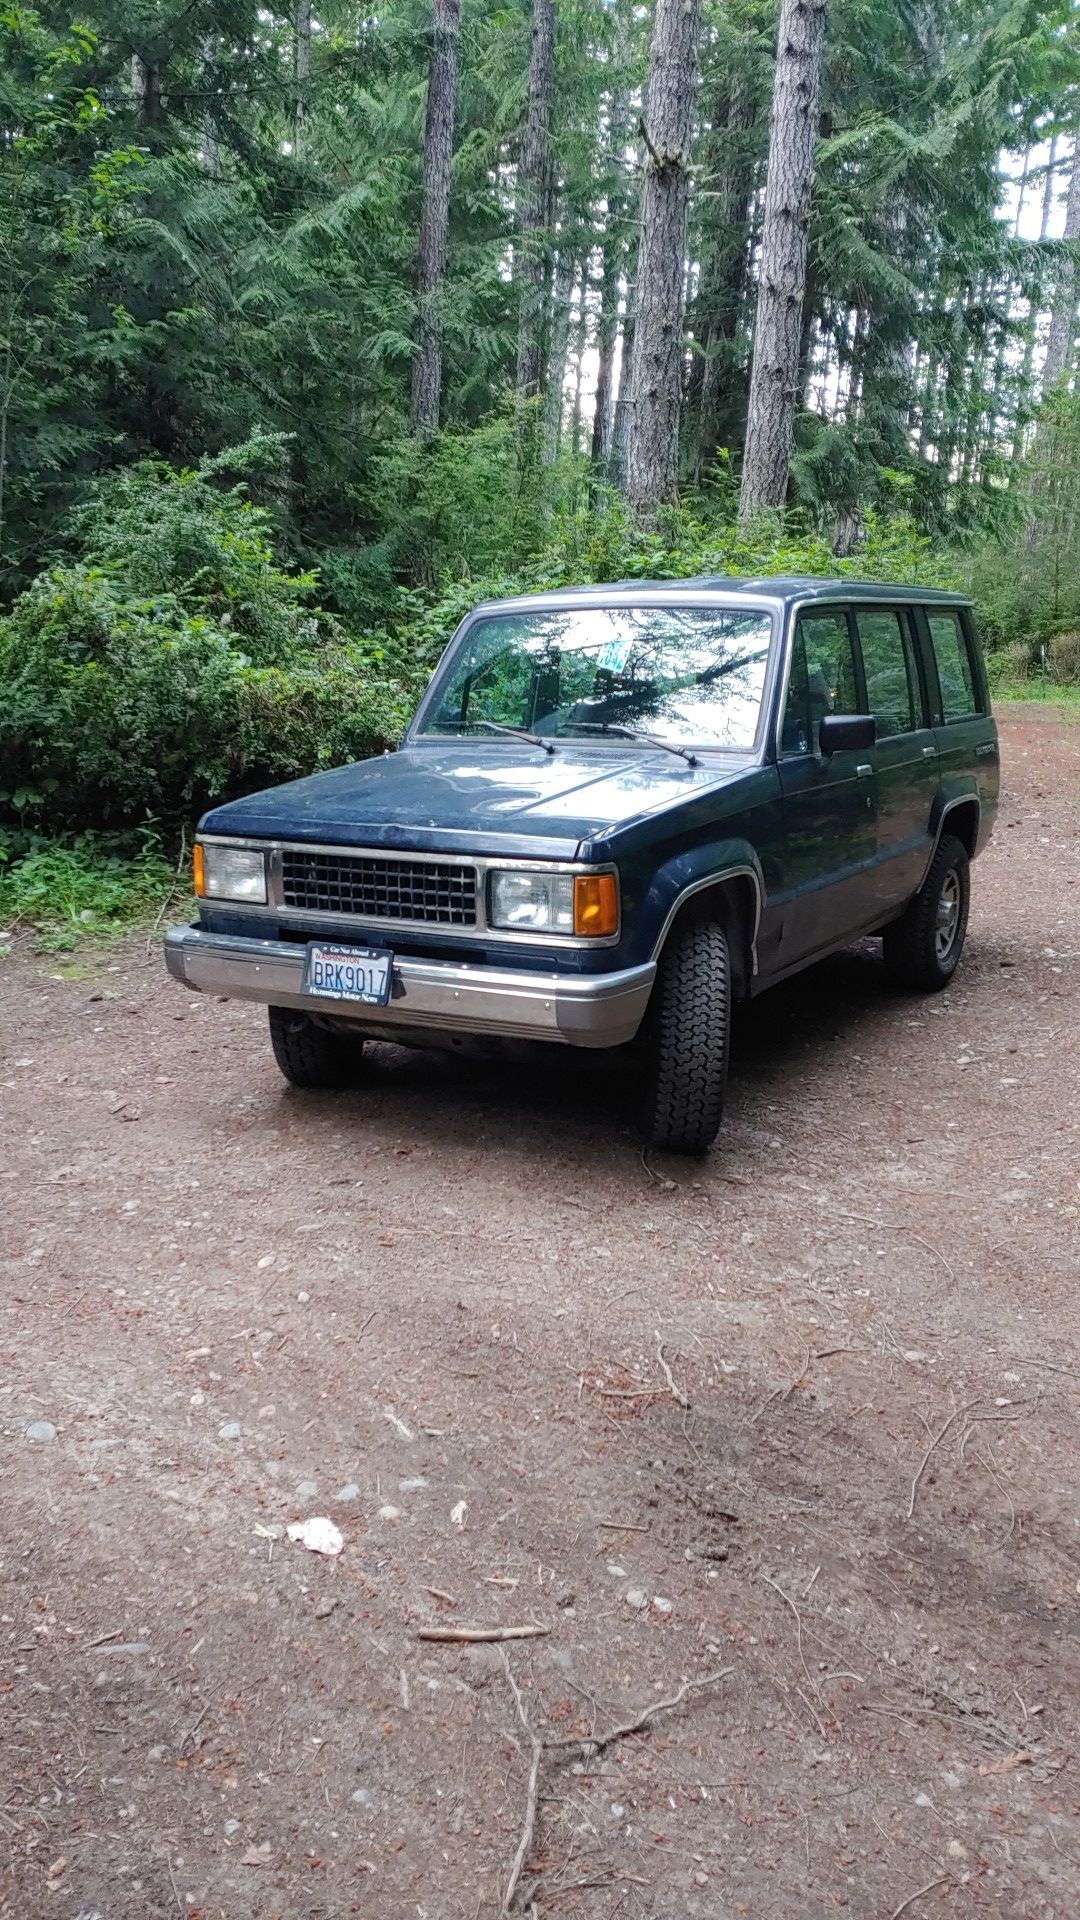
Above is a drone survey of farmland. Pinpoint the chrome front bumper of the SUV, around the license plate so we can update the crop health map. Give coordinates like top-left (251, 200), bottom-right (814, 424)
top-left (165, 927), bottom-right (655, 1046)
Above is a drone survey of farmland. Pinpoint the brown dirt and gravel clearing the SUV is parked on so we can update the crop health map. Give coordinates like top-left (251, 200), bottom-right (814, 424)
top-left (0, 708), bottom-right (1080, 1920)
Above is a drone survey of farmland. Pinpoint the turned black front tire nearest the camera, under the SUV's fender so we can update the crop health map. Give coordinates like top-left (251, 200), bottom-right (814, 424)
top-left (642, 920), bottom-right (732, 1154)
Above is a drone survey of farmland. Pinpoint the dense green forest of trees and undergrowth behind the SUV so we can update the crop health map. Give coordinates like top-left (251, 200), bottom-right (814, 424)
top-left (0, 0), bottom-right (1080, 887)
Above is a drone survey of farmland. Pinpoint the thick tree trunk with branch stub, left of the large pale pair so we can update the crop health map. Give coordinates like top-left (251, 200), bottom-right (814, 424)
top-left (626, 0), bottom-right (701, 522)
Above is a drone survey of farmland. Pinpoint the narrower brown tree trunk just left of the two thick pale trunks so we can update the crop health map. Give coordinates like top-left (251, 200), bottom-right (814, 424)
top-left (515, 0), bottom-right (555, 412)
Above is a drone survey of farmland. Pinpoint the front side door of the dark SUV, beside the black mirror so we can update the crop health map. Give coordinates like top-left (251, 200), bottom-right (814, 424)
top-left (776, 607), bottom-right (878, 968)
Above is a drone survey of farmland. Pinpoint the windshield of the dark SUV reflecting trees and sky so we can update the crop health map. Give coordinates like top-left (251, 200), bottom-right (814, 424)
top-left (419, 607), bottom-right (773, 751)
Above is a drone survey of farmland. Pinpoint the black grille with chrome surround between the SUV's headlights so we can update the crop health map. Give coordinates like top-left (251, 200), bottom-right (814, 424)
top-left (281, 849), bottom-right (477, 927)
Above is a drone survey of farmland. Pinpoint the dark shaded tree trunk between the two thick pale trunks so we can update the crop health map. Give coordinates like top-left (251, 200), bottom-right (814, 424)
top-left (694, 71), bottom-right (753, 478)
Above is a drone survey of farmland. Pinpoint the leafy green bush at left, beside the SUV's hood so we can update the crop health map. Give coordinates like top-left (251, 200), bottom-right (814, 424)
top-left (0, 447), bottom-right (413, 829)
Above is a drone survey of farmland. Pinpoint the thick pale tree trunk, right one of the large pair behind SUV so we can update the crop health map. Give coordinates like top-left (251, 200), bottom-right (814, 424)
top-left (738, 0), bottom-right (826, 520)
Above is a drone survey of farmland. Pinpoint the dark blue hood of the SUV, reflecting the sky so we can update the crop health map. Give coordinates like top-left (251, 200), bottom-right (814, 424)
top-left (200, 741), bottom-right (746, 858)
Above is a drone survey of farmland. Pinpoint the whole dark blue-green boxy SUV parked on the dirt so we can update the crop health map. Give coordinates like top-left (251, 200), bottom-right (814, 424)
top-left (165, 578), bottom-right (997, 1152)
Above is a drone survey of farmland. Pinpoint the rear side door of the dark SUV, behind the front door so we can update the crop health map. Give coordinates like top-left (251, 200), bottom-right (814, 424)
top-left (855, 605), bottom-right (938, 920)
